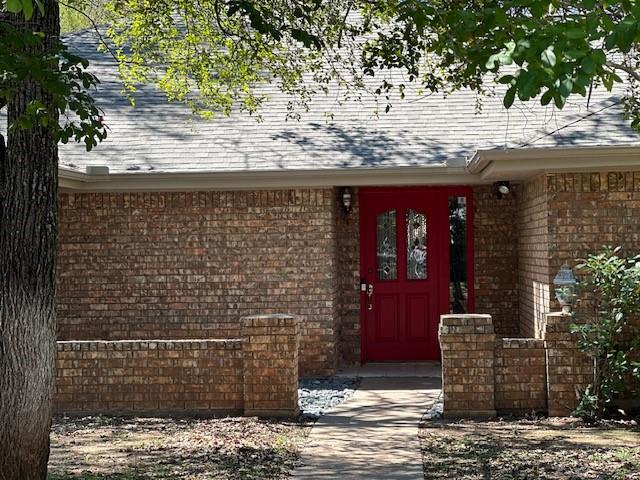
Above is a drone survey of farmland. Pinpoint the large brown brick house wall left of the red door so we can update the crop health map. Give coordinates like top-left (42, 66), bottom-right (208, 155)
top-left (58, 189), bottom-right (338, 374)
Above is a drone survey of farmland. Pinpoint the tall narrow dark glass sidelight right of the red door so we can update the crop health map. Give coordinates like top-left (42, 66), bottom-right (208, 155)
top-left (449, 197), bottom-right (469, 313)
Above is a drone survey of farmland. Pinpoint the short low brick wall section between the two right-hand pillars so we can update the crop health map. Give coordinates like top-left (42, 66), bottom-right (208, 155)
top-left (495, 338), bottom-right (547, 413)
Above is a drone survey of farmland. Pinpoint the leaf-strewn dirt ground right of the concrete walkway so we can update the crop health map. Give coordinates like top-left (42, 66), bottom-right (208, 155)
top-left (420, 418), bottom-right (640, 480)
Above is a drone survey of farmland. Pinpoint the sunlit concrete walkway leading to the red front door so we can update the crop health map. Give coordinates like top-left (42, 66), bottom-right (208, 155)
top-left (293, 377), bottom-right (440, 480)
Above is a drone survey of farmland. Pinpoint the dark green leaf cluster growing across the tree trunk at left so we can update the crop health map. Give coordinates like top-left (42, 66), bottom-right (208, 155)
top-left (0, 3), bottom-right (107, 150)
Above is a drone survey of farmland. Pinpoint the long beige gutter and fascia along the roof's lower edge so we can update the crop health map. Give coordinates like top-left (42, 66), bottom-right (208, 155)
top-left (59, 145), bottom-right (640, 192)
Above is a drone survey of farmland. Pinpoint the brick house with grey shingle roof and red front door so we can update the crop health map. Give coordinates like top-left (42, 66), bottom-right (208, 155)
top-left (43, 31), bottom-right (640, 414)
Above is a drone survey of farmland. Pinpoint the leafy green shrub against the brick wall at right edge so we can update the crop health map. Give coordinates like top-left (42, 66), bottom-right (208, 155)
top-left (571, 247), bottom-right (640, 419)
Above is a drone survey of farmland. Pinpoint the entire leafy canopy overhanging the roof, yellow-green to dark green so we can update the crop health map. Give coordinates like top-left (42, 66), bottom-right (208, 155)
top-left (105, 0), bottom-right (640, 128)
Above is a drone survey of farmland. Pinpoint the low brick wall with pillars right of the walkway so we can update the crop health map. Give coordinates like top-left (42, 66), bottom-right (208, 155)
top-left (439, 313), bottom-right (592, 417)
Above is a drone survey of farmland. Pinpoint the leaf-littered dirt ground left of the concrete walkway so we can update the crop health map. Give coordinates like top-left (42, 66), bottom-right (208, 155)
top-left (48, 416), bottom-right (307, 480)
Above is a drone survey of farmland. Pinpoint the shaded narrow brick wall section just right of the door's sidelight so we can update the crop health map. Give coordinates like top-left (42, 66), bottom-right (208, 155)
top-left (473, 185), bottom-right (518, 336)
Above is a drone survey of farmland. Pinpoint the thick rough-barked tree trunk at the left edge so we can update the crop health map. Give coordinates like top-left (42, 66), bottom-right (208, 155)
top-left (0, 0), bottom-right (60, 480)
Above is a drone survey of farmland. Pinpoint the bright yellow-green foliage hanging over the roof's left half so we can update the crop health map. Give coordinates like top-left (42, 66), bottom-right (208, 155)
top-left (108, 0), bottom-right (342, 117)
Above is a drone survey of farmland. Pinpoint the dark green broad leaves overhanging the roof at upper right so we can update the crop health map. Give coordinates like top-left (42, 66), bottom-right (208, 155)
top-left (364, 0), bottom-right (640, 124)
